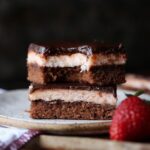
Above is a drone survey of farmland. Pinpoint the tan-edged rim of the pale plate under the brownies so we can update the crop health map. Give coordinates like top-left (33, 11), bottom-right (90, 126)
top-left (0, 89), bottom-right (111, 132)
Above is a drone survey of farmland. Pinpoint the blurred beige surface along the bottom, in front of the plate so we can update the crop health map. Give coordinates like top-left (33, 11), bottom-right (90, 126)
top-left (22, 135), bottom-right (150, 150)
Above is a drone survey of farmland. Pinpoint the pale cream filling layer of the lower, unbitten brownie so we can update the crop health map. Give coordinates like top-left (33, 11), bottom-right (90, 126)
top-left (29, 89), bottom-right (116, 105)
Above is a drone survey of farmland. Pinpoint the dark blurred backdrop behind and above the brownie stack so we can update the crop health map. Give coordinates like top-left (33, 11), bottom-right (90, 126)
top-left (0, 0), bottom-right (150, 89)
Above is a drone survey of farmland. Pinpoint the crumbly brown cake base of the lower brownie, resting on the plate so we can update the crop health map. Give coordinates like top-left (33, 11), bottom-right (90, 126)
top-left (30, 100), bottom-right (115, 120)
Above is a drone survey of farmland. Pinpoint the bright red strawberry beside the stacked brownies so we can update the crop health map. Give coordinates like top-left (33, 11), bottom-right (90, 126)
top-left (110, 96), bottom-right (150, 141)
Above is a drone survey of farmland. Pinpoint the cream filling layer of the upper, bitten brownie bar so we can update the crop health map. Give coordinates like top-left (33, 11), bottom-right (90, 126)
top-left (27, 51), bottom-right (126, 71)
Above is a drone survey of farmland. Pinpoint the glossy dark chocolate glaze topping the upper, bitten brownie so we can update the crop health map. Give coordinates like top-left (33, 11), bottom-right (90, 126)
top-left (28, 41), bottom-right (125, 56)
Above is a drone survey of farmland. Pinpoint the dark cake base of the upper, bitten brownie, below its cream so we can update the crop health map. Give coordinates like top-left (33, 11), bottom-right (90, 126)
top-left (28, 64), bottom-right (125, 86)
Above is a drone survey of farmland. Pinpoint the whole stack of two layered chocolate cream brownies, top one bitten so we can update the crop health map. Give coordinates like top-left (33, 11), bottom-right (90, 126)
top-left (27, 42), bottom-right (126, 120)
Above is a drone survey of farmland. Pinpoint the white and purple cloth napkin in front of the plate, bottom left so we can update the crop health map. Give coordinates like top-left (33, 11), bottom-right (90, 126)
top-left (0, 89), bottom-right (39, 150)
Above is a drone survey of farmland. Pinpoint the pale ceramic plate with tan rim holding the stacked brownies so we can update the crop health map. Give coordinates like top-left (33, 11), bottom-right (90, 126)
top-left (0, 90), bottom-right (150, 134)
